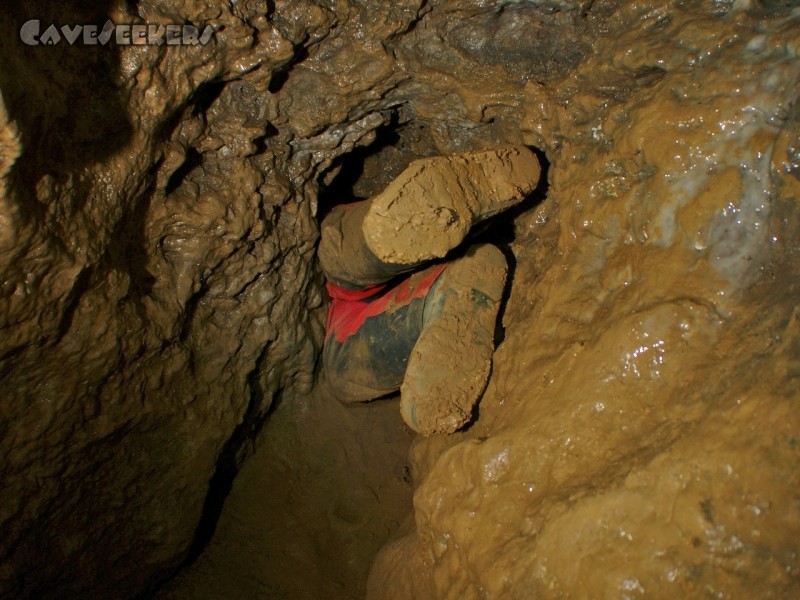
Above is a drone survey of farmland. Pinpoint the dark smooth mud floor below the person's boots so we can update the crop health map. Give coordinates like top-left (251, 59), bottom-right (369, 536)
top-left (155, 386), bottom-right (416, 600)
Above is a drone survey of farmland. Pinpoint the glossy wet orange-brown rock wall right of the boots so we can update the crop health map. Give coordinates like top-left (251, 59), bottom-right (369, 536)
top-left (369, 4), bottom-right (800, 598)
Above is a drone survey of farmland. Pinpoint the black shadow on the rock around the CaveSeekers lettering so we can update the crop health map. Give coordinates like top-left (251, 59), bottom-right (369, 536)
top-left (0, 0), bottom-right (133, 222)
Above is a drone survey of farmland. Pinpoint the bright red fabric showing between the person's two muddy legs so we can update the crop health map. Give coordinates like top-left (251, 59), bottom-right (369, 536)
top-left (325, 264), bottom-right (447, 343)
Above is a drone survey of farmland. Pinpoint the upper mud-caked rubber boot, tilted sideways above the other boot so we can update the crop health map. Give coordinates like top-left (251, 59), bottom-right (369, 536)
top-left (363, 146), bottom-right (540, 265)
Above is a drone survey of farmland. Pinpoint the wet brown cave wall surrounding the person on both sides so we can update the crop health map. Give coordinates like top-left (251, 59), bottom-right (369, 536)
top-left (0, 0), bottom-right (800, 598)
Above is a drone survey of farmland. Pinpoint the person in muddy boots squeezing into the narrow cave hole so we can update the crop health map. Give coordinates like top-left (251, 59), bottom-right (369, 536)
top-left (319, 146), bottom-right (541, 435)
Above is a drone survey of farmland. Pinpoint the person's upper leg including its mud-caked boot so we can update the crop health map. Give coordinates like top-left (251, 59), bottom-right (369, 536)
top-left (319, 146), bottom-right (540, 289)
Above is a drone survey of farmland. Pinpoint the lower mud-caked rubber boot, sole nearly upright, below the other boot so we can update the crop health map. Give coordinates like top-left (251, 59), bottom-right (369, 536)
top-left (400, 244), bottom-right (508, 435)
